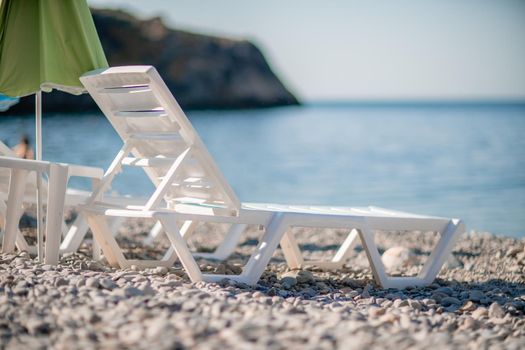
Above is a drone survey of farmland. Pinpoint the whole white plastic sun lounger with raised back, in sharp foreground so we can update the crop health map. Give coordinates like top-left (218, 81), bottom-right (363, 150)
top-left (80, 66), bottom-right (464, 288)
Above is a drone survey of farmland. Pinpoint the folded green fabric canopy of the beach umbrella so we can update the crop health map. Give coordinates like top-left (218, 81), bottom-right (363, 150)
top-left (0, 0), bottom-right (108, 97)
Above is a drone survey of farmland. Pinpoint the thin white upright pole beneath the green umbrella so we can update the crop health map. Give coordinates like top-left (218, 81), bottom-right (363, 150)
top-left (35, 91), bottom-right (44, 262)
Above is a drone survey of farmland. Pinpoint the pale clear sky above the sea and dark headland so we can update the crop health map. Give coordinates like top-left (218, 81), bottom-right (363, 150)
top-left (88, 0), bottom-right (525, 101)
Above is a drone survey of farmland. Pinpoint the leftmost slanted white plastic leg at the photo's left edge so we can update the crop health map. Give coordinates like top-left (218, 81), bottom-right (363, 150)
top-left (2, 169), bottom-right (27, 253)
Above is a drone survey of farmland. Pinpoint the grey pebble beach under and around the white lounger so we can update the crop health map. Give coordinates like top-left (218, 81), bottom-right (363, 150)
top-left (0, 222), bottom-right (525, 349)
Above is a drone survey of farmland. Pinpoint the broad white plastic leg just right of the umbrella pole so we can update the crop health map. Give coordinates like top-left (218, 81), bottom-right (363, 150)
top-left (44, 164), bottom-right (68, 265)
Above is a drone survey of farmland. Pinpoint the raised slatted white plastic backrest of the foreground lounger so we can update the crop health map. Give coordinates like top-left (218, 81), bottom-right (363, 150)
top-left (80, 66), bottom-right (240, 211)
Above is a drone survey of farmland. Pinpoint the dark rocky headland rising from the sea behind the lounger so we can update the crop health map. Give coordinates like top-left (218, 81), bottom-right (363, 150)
top-left (3, 9), bottom-right (298, 114)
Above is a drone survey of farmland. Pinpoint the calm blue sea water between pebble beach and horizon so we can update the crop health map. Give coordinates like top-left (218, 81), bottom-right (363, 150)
top-left (0, 105), bottom-right (525, 237)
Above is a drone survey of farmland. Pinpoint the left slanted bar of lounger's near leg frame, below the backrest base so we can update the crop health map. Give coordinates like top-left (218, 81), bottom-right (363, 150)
top-left (159, 216), bottom-right (202, 282)
